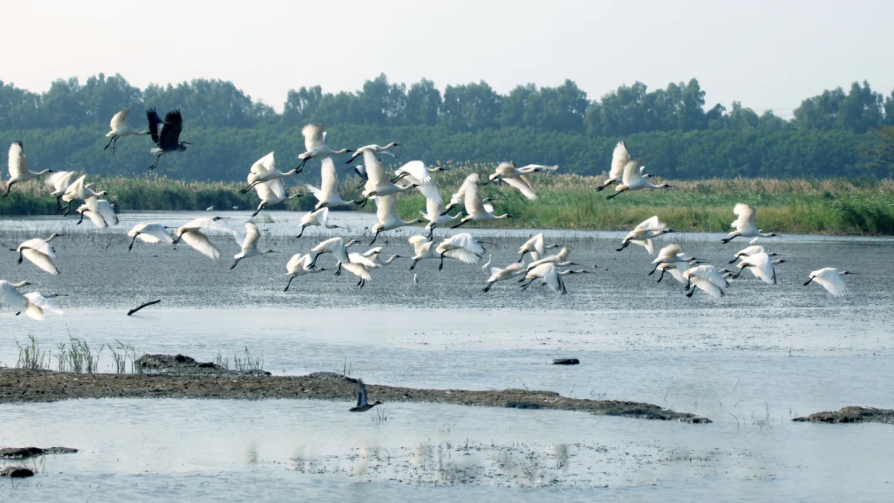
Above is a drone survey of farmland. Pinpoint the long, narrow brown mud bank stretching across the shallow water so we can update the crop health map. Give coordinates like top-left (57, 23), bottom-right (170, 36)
top-left (0, 355), bottom-right (711, 423)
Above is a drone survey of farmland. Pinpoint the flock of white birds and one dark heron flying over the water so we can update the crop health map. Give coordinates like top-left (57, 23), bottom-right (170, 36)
top-left (0, 109), bottom-right (853, 320)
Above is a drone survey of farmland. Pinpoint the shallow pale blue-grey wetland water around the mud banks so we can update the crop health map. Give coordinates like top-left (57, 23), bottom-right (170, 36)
top-left (0, 212), bottom-right (894, 501)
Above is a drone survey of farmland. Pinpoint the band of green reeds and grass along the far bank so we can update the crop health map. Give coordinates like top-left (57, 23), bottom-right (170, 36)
top-left (0, 163), bottom-right (894, 235)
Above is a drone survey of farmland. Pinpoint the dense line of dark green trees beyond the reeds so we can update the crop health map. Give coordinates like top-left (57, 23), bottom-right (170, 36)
top-left (0, 74), bottom-right (894, 180)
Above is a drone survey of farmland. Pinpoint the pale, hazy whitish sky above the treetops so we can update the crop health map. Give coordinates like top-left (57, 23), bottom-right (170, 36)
top-left (0, 0), bottom-right (894, 116)
